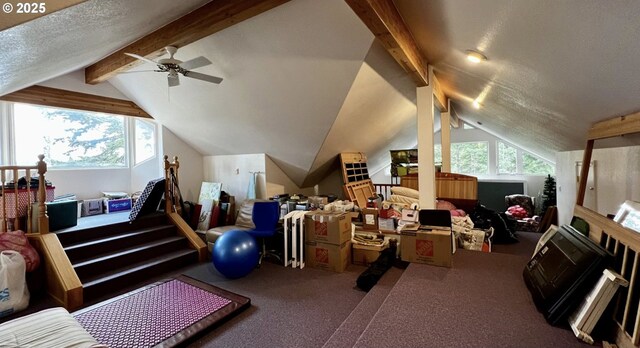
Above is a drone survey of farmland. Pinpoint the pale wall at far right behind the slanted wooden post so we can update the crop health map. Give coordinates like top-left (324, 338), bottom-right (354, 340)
top-left (556, 146), bottom-right (640, 224)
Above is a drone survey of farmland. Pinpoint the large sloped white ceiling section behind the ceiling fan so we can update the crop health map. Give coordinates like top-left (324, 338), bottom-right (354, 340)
top-left (110, 0), bottom-right (373, 185)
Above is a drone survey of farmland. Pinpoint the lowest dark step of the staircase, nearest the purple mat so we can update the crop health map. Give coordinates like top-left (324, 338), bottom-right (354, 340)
top-left (82, 248), bottom-right (198, 302)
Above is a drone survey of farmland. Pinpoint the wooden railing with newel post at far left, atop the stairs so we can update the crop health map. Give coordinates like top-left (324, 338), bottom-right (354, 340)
top-left (0, 155), bottom-right (49, 234)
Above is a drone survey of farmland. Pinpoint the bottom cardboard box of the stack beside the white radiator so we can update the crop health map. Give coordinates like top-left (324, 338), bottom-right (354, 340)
top-left (304, 241), bottom-right (351, 273)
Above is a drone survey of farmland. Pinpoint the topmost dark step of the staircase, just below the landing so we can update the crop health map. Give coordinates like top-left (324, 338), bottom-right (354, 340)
top-left (55, 214), bottom-right (167, 246)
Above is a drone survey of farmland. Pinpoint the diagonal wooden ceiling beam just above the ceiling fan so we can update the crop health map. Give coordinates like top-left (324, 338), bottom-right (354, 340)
top-left (85, 0), bottom-right (289, 84)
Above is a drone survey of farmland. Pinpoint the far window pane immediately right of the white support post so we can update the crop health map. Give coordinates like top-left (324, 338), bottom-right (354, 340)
top-left (451, 141), bottom-right (489, 174)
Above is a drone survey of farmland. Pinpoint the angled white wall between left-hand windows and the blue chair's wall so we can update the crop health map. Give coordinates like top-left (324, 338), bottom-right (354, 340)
top-left (160, 126), bottom-right (202, 202)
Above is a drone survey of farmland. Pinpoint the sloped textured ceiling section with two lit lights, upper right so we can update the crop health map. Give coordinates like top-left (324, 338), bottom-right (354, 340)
top-left (395, 0), bottom-right (640, 159)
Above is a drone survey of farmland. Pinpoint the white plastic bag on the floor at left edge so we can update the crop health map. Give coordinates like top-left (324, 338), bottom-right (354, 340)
top-left (0, 250), bottom-right (29, 317)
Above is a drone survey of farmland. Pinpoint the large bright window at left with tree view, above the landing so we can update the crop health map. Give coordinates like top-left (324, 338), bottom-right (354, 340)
top-left (13, 103), bottom-right (127, 168)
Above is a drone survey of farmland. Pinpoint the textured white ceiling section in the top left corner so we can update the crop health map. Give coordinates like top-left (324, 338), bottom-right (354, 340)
top-left (0, 0), bottom-right (208, 95)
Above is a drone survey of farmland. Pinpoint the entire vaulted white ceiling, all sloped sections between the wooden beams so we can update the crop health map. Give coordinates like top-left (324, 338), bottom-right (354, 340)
top-left (0, 0), bottom-right (640, 186)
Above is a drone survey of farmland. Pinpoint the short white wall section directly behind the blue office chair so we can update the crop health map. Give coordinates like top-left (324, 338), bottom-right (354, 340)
top-left (203, 153), bottom-right (267, 207)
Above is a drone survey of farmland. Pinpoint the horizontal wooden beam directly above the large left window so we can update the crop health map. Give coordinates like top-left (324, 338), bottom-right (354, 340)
top-left (0, 86), bottom-right (153, 118)
